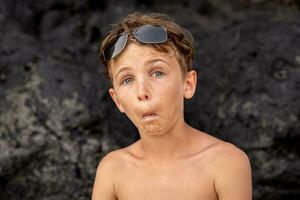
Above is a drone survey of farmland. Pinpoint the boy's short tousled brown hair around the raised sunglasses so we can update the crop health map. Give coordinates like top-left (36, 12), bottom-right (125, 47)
top-left (100, 12), bottom-right (194, 78)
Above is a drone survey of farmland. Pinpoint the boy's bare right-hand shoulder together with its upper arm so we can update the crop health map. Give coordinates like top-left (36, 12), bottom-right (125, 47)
top-left (191, 131), bottom-right (252, 200)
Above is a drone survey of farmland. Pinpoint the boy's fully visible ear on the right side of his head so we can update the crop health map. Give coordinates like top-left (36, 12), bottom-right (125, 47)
top-left (184, 70), bottom-right (197, 99)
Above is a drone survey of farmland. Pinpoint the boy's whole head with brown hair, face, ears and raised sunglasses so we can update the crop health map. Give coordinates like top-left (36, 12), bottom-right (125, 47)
top-left (100, 13), bottom-right (197, 136)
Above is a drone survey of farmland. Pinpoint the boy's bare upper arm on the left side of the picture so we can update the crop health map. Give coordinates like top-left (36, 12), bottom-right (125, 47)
top-left (92, 153), bottom-right (117, 200)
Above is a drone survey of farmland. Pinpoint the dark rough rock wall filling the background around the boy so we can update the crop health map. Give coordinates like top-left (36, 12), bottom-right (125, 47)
top-left (0, 0), bottom-right (300, 200)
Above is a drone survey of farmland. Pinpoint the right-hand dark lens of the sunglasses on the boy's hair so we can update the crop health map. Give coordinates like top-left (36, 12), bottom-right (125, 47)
top-left (133, 25), bottom-right (168, 43)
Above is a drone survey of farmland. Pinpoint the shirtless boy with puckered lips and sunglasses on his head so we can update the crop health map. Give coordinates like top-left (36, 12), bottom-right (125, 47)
top-left (92, 13), bottom-right (252, 200)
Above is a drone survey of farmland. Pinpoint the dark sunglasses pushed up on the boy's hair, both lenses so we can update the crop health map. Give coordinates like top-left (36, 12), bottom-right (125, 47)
top-left (104, 24), bottom-right (168, 61)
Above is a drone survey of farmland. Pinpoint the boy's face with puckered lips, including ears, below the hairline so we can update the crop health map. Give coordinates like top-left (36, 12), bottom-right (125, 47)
top-left (109, 42), bottom-right (196, 136)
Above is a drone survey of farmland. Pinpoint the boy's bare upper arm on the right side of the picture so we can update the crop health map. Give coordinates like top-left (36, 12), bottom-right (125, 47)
top-left (215, 145), bottom-right (252, 200)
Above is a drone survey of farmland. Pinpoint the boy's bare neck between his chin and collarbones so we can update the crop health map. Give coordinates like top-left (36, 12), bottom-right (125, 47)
top-left (140, 121), bottom-right (191, 160)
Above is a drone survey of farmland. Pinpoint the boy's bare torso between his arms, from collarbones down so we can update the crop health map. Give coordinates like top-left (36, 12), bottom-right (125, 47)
top-left (111, 130), bottom-right (222, 200)
